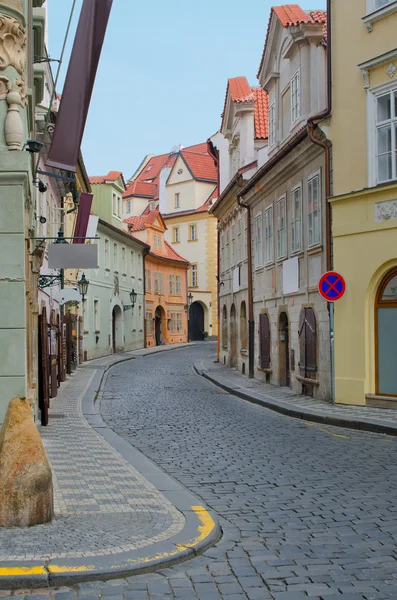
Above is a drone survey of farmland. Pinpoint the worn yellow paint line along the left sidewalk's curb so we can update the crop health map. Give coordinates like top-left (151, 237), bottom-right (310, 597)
top-left (0, 506), bottom-right (215, 577)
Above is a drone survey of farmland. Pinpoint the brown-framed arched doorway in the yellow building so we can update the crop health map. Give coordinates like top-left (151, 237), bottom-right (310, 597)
top-left (375, 269), bottom-right (397, 396)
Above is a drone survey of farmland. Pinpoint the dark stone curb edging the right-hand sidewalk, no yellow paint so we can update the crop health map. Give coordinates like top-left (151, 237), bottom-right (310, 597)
top-left (193, 364), bottom-right (397, 436)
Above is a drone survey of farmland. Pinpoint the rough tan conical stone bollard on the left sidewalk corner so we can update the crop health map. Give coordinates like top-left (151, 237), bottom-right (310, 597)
top-left (0, 398), bottom-right (54, 527)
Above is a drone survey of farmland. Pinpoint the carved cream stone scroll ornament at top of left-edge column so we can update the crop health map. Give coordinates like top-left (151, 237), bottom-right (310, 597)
top-left (0, 15), bottom-right (26, 75)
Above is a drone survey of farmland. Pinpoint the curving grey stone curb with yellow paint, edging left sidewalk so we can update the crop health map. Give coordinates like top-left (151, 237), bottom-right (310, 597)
top-left (0, 344), bottom-right (222, 590)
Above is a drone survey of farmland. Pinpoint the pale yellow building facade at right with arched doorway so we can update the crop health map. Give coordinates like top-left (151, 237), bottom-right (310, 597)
top-left (330, 0), bottom-right (397, 408)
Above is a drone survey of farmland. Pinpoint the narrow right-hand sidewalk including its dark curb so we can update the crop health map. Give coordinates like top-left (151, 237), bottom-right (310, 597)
top-left (194, 359), bottom-right (397, 436)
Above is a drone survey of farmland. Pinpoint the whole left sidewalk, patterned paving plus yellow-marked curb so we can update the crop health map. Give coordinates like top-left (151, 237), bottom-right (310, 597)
top-left (0, 344), bottom-right (220, 589)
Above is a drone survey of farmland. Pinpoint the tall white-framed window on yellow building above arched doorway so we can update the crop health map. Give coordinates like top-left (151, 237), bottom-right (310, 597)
top-left (376, 87), bottom-right (397, 183)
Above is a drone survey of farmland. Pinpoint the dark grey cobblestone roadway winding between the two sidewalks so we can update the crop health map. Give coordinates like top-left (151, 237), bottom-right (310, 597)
top-left (4, 344), bottom-right (397, 600)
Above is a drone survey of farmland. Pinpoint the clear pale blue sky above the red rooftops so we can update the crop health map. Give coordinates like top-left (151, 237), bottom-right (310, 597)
top-left (48, 0), bottom-right (325, 178)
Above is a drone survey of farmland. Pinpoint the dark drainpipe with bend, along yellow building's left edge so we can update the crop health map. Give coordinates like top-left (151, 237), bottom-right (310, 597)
top-left (307, 0), bottom-right (335, 404)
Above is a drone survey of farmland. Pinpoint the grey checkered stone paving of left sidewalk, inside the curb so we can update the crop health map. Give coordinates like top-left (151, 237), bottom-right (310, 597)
top-left (0, 360), bottom-right (185, 560)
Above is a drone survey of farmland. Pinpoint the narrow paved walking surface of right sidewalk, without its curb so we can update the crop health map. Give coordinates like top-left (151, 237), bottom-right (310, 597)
top-left (196, 358), bottom-right (397, 425)
